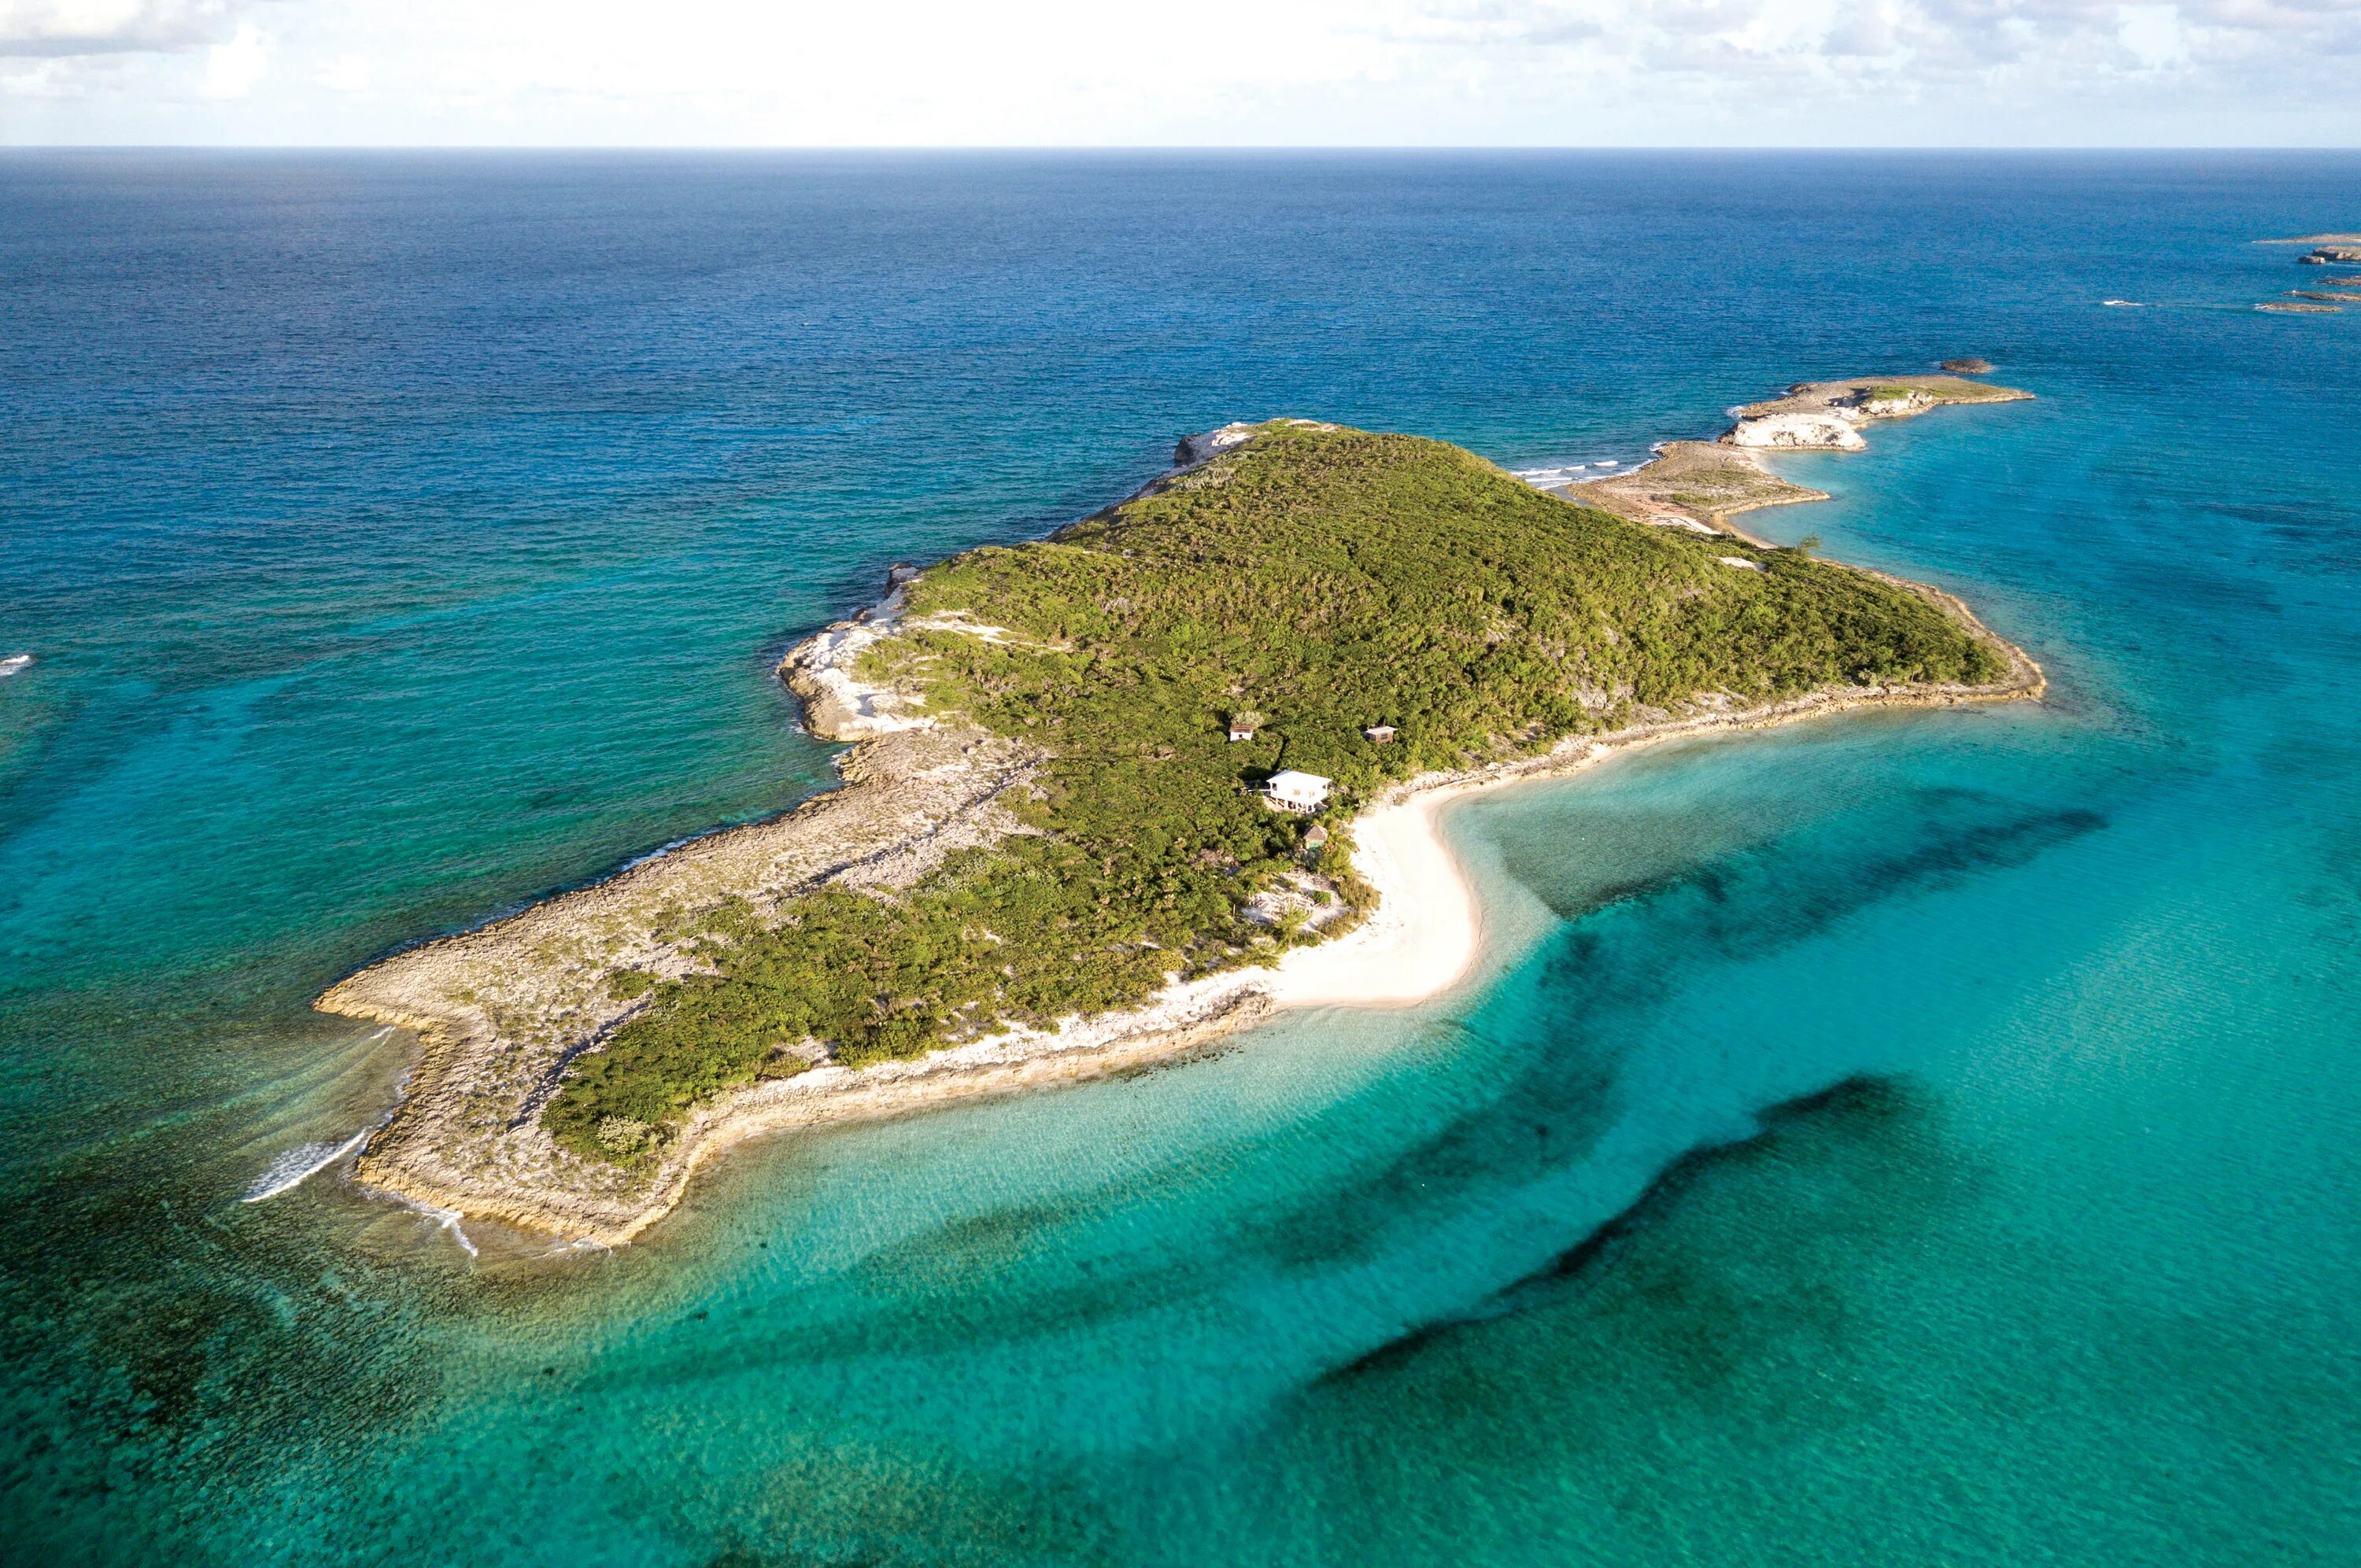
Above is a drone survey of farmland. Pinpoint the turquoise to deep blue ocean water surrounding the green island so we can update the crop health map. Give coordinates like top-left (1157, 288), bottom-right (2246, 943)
top-left (0, 151), bottom-right (2361, 1568)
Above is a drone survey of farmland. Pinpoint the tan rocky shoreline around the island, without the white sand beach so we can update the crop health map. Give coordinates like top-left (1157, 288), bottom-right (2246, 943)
top-left (316, 378), bottom-right (2042, 1245)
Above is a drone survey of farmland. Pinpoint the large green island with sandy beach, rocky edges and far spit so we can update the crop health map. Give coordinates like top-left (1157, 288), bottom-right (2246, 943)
top-left (316, 375), bottom-right (2042, 1245)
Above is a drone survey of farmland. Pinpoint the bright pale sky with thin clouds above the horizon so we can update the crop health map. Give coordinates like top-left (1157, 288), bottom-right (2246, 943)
top-left (0, 0), bottom-right (2361, 146)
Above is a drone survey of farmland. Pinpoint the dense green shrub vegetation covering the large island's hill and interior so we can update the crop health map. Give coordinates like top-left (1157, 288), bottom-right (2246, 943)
top-left (545, 422), bottom-right (2007, 1162)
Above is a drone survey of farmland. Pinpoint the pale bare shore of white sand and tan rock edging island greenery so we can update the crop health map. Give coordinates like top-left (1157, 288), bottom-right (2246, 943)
top-left (316, 394), bottom-right (2042, 1245)
